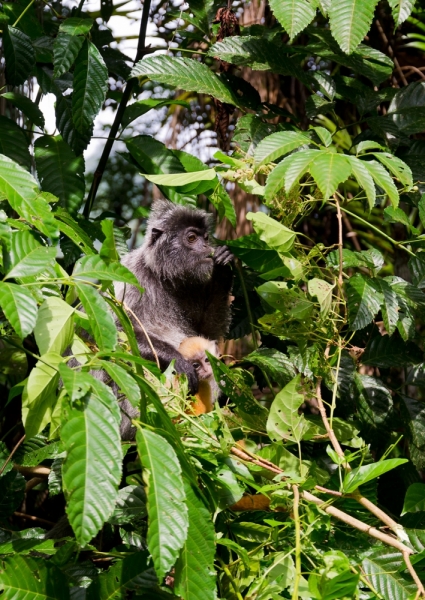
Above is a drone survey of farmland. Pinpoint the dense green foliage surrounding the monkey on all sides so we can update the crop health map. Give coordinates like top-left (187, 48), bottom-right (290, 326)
top-left (0, 0), bottom-right (425, 600)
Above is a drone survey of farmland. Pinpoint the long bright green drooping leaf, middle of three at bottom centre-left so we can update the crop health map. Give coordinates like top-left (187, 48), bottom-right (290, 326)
top-left (136, 429), bottom-right (189, 581)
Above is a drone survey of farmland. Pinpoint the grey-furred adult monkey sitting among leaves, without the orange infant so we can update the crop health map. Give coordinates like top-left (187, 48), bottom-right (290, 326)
top-left (115, 200), bottom-right (233, 436)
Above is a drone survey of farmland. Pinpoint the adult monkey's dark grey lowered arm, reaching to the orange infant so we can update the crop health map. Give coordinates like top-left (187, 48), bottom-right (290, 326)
top-left (136, 328), bottom-right (198, 394)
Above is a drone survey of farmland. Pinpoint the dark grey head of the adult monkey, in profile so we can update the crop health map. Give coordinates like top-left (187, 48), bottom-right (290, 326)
top-left (143, 200), bottom-right (214, 283)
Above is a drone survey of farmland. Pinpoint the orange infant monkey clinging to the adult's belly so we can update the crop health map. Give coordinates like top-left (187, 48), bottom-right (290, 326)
top-left (179, 337), bottom-right (219, 415)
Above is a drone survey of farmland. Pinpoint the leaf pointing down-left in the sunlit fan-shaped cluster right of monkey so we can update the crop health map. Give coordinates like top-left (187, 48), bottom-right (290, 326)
top-left (264, 150), bottom-right (320, 200)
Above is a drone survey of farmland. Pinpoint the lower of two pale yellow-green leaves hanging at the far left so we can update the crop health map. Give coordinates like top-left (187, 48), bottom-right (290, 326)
top-left (22, 352), bottom-right (63, 439)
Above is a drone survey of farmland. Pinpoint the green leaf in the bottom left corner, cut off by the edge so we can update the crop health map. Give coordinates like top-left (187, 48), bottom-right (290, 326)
top-left (0, 554), bottom-right (70, 600)
